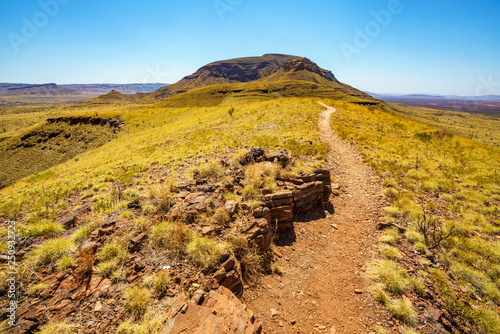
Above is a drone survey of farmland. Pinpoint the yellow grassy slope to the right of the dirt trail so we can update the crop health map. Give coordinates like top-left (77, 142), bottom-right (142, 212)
top-left (331, 101), bottom-right (500, 333)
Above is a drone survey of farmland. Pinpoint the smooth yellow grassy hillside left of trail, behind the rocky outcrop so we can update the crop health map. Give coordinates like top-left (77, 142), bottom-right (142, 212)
top-left (0, 99), bottom-right (324, 218)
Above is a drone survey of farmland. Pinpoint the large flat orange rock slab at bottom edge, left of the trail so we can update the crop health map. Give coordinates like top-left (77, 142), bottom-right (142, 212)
top-left (170, 287), bottom-right (262, 334)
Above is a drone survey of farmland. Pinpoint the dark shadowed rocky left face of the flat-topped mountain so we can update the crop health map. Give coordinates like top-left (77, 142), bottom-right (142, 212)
top-left (146, 54), bottom-right (299, 101)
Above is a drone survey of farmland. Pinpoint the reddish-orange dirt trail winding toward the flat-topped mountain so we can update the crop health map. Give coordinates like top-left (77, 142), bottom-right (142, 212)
top-left (243, 102), bottom-right (390, 334)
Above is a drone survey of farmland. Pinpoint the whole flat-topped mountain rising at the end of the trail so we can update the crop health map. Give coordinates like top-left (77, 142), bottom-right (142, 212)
top-left (147, 54), bottom-right (380, 106)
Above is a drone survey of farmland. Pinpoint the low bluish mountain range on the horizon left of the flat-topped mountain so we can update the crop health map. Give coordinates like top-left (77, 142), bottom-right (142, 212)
top-left (0, 83), bottom-right (168, 96)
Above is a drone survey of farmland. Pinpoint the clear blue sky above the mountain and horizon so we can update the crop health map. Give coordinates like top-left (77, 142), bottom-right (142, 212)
top-left (0, 0), bottom-right (500, 95)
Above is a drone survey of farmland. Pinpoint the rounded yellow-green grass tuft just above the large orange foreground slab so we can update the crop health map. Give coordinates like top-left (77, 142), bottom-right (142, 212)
top-left (186, 235), bottom-right (230, 268)
